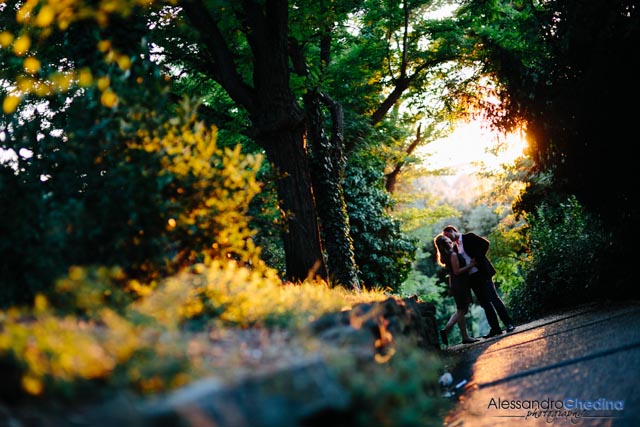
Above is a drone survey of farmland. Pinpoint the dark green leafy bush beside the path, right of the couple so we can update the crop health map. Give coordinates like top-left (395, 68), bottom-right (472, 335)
top-left (507, 197), bottom-right (613, 318)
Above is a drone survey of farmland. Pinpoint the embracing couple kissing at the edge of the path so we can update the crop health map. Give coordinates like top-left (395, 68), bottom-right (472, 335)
top-left (433, 225), bottom-right (515, 346)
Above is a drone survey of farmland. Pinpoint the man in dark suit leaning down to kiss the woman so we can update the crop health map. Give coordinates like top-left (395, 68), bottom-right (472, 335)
top-left (442, 225), bottom-right (515, 338)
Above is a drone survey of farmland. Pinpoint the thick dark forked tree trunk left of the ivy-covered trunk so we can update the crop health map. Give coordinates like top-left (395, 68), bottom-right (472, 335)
top-left (181, 0), bottom-right (327, 281)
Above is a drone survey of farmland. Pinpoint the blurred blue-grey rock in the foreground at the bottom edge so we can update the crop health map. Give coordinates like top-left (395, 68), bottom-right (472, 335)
top-left (142, 359), bottom-right (349, 427)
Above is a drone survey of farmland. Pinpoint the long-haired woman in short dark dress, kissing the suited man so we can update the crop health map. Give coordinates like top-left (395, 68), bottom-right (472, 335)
top-left (433, 234), bottom-right (478, 346)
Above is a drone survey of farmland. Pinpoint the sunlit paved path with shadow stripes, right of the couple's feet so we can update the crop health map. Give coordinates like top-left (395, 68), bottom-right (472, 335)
top-left (444, 302), bottom-right (640, 427)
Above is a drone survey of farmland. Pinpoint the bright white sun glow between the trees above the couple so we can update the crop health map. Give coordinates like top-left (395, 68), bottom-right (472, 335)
top-left (418, 121), bottom-right (527, 174)
